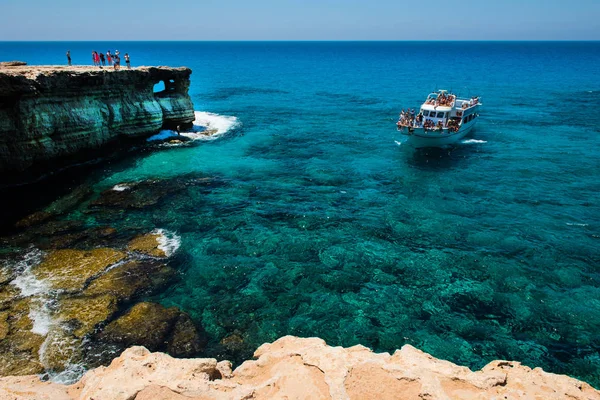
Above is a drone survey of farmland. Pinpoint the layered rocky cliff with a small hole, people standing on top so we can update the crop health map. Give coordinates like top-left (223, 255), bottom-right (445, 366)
top-left (0, 65), bottom-right (194, 175)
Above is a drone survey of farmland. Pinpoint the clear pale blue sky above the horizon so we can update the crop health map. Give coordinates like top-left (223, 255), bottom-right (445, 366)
top-left (0, 0), bottom-right (600, 41)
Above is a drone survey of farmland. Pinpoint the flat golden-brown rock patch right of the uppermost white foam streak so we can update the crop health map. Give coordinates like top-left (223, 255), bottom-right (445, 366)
top-left (33, 248), bottom-right (125, 291)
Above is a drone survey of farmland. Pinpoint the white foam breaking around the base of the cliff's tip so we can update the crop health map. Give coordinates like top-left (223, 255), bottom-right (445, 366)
top-left (146, 111), bottom-right (239, 142)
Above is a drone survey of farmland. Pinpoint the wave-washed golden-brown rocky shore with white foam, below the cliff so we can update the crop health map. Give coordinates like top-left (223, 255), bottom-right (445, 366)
top-left (0, 176), bottom-right (220, 381)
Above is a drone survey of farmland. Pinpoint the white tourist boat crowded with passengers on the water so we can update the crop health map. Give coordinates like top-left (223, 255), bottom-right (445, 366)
top-left (397, 90), bottom-right (481, 148)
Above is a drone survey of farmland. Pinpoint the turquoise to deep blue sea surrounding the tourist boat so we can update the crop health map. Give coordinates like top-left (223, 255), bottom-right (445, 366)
top-left (0, 42), bottom-right (600, 388)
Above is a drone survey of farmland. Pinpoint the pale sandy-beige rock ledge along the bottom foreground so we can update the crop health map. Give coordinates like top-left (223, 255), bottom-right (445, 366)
top-left (0, 336), bottom-right (600, 400)
